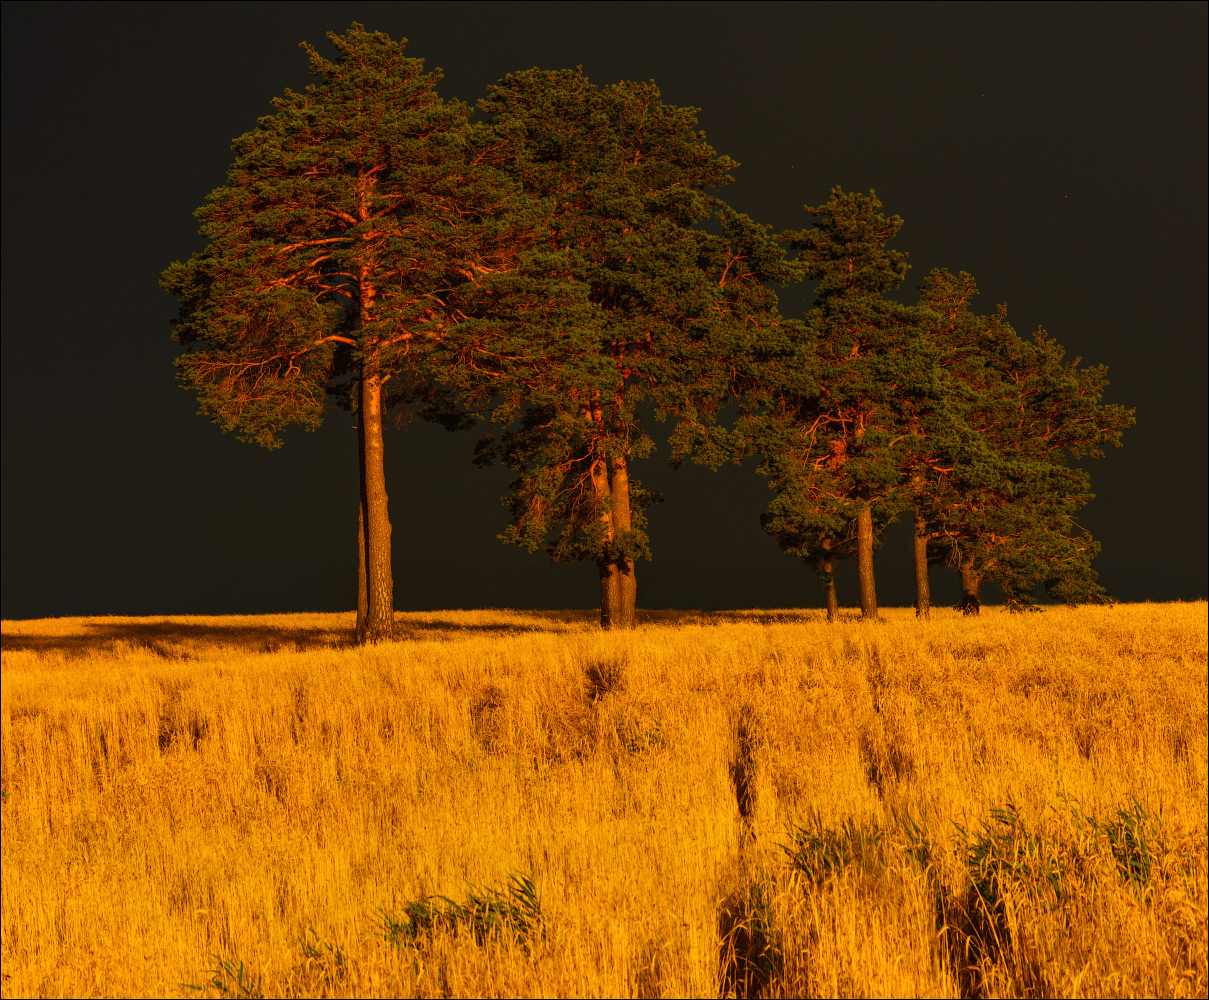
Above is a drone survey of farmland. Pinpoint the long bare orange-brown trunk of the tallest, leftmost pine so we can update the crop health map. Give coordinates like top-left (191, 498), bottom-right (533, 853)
top-left (358, 362), bottom-right (394, 642)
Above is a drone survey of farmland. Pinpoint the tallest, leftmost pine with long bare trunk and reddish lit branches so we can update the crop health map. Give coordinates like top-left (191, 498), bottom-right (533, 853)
top-left (162, 29), bottom-right (511, 641)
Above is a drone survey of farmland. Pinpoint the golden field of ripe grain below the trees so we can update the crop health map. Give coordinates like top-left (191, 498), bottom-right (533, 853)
top-left (2, 602), bottom-right (1209, 996)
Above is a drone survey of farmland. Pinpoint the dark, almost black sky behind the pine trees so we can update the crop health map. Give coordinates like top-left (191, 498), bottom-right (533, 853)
top-left (0, 2), bottom-right (1209, 618)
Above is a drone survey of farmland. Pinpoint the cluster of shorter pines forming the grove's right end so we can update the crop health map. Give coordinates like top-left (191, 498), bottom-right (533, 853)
top-left (740, 189), bottom-right (1133, 614)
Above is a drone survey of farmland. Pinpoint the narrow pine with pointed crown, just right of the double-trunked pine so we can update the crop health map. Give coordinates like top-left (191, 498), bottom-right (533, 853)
top-left (741, 187), bottom-right (939, 618)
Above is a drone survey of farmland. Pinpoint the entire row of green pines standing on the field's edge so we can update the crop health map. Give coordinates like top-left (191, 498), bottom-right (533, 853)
top-left (162, 23), bottom-right (1133, 642)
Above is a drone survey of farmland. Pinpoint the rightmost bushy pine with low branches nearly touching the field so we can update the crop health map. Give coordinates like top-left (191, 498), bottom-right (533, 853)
top-left (918, 271), bottom-right (1134, 613)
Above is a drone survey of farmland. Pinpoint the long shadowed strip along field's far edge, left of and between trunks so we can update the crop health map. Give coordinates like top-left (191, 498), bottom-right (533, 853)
top-left (0, 608), bottom-right (821, 660)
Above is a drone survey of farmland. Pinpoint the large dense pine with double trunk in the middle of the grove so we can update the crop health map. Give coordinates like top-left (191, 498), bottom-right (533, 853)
top-left (446, 70), bottom-right (792, 628)
